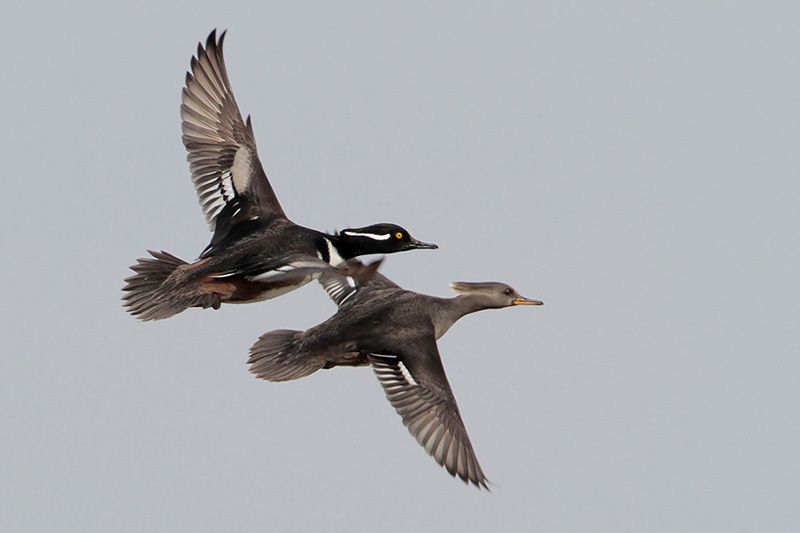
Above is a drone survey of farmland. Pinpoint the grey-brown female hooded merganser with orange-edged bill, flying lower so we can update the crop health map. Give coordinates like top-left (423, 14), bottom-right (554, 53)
top-left (248, 261), bottom-right (542, 488)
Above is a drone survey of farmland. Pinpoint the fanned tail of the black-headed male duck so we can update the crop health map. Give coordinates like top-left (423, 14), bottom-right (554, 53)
top-left (122, 250), bottom-right (219, 320)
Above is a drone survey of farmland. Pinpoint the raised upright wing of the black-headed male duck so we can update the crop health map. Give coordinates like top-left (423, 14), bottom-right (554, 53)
top-left (181, 30), bottom-right (285, 230)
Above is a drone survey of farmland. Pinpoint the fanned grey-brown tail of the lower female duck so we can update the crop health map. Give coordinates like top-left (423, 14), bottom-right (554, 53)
top-left (247, 329), bottom-right (325, 381)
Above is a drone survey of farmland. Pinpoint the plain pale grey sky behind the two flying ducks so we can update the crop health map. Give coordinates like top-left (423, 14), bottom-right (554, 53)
top-left (0, 2), bottom-right (800, 532)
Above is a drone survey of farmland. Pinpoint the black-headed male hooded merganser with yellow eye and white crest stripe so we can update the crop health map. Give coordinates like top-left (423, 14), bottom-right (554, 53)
top-left (123, 30), bottom-right (437, 320)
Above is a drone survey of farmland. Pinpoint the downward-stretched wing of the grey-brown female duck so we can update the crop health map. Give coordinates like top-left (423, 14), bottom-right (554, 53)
top-left (369, 331), bottom-right (488, 489)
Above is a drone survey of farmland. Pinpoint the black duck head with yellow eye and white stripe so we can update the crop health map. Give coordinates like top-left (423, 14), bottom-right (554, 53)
top-left (338, 224), bottom-right (438, 258)
